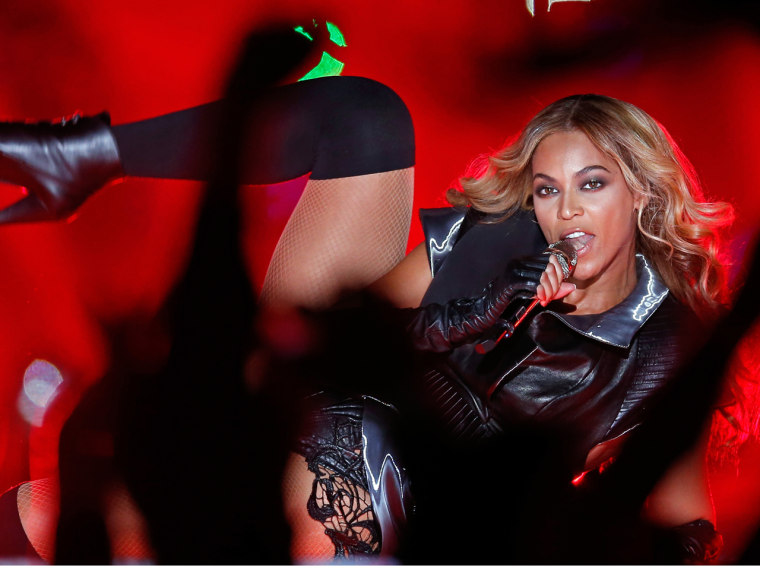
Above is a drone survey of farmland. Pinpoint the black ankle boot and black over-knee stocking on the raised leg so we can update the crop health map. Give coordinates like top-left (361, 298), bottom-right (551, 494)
top-left (0, 77), bottom-right (414, 223)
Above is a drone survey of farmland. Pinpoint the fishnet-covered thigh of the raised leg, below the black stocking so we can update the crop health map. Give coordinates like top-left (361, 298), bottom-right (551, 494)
top-left (261, 167), bottom-right (414, 307)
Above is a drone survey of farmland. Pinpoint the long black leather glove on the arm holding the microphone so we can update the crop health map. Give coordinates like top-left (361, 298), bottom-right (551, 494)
top-left (406, 254), bottom-right (549, 352)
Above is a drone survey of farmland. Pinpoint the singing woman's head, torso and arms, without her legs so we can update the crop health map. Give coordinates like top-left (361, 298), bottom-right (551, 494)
top-left (377, 91), bottom-right (731, 560)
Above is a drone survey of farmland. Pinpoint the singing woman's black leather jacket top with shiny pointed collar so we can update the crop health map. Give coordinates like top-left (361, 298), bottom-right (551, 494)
top-left (421, 208), bottom-right (696, 471)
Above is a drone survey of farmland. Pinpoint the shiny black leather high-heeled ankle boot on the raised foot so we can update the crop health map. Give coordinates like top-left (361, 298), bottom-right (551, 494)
top-left (0, 113), bottom-right (123, 223)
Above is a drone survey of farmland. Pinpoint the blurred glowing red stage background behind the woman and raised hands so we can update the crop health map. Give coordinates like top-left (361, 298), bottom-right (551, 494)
top-left (0, 0), bottom-right (760, 560)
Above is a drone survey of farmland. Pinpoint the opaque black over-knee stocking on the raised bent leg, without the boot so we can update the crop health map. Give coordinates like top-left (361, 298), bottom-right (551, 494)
top-left (112, 77), bottom-right (414, 184)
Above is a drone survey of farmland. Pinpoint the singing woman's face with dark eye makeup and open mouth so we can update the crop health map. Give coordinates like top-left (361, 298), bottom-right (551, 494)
top-left (532, 130), bottom-right (639, 288)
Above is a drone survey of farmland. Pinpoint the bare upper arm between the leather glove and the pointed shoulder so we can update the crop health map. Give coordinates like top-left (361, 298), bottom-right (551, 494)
top-left (369, 243), bottom-right (433, 309)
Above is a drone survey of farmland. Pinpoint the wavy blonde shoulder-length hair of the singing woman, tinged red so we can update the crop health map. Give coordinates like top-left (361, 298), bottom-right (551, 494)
top-left (447, 94), bottom-right (733, 315)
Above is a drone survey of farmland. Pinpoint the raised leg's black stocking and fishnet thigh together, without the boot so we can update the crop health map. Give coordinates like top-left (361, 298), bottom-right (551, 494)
top-left (112, 77), bottom-right (414, 306)
